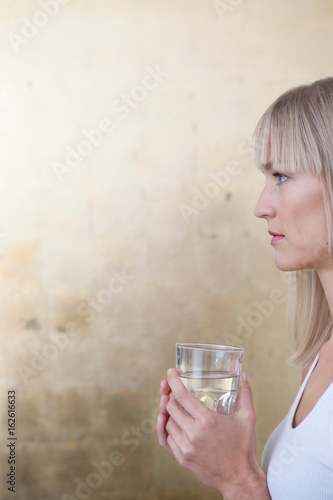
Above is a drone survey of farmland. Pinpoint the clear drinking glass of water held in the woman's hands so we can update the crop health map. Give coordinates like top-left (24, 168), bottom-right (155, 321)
top-left (176, 342), bottom-right (244, 415)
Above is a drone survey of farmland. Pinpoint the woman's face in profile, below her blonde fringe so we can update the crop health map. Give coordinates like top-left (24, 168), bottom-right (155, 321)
top-left (254, 162), bottom-right (329, 271)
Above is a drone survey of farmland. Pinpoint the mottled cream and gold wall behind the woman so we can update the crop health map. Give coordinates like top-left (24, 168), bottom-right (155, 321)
top-left (0, 0), bottom-right (333, 500)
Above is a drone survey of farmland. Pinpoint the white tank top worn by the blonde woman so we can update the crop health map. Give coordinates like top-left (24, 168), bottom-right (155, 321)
top-left (261, 353), bottom-right (333, 500)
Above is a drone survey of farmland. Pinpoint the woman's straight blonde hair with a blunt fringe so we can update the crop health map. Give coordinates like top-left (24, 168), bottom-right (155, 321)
top-left (253, 77), bottom-right (333, 368)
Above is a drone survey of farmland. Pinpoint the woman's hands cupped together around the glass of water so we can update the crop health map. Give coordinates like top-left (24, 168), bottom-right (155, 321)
top-left (157, 370), bottom-right (270, 499)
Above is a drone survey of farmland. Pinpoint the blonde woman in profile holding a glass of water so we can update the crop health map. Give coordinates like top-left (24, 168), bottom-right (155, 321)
top-left (157, 78), bottom-right (333, 500)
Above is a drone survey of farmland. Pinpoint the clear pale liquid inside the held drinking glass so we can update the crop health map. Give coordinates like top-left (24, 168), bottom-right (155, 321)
top-left (180, 372), bottom-right (239, 415)
